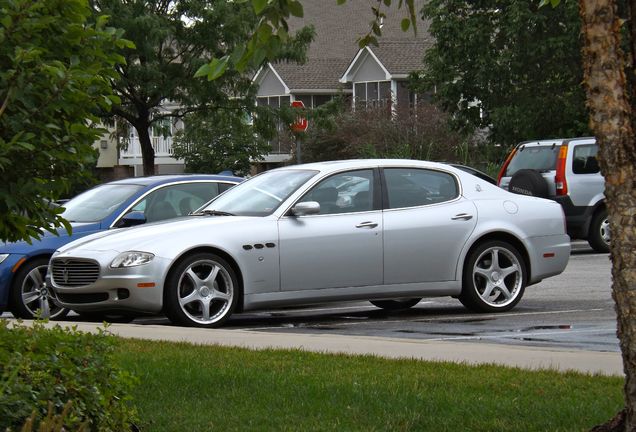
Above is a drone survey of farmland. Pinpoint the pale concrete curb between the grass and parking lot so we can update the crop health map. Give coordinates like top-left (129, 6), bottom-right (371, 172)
top-left (23, 321), bottom-right (623, 376)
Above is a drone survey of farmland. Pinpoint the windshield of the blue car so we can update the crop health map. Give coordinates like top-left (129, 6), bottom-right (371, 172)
top-left (62, 184), bottom-right (143, 222)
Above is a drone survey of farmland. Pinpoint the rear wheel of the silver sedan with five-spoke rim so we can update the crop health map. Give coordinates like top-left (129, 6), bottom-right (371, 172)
top-left (459, 241), bottom-right (528, 312)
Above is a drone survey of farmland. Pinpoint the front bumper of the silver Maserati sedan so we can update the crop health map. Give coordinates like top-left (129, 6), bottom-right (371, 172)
top-left (48, 252), bottom-right (170, 314)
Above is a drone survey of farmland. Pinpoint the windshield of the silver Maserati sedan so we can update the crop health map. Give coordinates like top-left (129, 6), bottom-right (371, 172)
top-left (200, 169), bottom-right (318, 216)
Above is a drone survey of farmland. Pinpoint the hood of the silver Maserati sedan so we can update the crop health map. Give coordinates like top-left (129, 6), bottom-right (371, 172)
top-left (58, 216), bottom-right (254, 255)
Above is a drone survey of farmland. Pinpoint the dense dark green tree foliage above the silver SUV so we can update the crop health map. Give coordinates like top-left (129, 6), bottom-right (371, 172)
top-left (417, 0), bottom-right (590, 145)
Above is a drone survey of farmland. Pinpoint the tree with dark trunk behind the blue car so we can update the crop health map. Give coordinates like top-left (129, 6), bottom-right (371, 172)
top-left (92, 0), bottom-right (313, 175)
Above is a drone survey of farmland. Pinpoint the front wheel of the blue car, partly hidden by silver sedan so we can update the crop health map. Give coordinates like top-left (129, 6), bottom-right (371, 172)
top-left (9, 257), bottom-right (68, 320)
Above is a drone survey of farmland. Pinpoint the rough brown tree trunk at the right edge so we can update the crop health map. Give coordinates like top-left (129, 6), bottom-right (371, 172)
top-left (579, 0), bottom-right (636, 431)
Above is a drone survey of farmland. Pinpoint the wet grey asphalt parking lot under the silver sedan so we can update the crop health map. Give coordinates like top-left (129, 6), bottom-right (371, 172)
top-left (3, 242), bottom-right (620, 352)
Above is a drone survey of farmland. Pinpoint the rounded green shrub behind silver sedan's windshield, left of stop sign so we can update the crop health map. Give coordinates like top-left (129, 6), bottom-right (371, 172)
top-left (172, 110), bottom-right (269, 175)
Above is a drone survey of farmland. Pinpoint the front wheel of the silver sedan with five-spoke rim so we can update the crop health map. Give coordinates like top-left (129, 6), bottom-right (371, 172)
top-left (164, 253), bottom-right (240, 328)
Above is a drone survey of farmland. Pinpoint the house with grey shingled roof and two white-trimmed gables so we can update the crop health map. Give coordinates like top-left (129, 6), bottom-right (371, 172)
top-left (95, 0), bottom-right (433, 174)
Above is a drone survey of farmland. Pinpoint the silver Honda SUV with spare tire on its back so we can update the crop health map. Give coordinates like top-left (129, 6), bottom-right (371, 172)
top-left (497, 137), bottom-right (610, 252)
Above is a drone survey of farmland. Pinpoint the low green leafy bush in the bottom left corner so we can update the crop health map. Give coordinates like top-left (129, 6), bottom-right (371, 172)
top-left (0, 320), bottom-right (137, 432)
